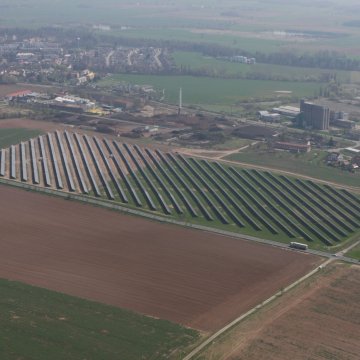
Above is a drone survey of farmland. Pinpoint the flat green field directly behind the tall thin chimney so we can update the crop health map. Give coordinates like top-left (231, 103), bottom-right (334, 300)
top-left (99, 74), bottom-right (321, 104)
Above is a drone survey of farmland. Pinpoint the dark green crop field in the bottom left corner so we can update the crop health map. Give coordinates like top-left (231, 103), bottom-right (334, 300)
top-left (0, 279), bottom-right (200, 360)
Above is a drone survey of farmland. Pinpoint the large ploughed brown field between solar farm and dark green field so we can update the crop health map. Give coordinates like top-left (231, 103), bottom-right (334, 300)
top-left (0, 185), bottom-right (319, 331)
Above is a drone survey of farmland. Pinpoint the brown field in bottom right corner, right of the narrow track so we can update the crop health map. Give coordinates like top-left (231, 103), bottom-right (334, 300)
top-left (198, 264), bottom-right (360, 360)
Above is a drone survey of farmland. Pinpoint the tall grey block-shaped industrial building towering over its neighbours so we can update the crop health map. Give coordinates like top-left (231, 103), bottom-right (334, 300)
top-left (300, 99), bottom-right (330, 130)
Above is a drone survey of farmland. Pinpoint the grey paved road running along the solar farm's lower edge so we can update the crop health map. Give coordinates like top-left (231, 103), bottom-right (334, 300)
top-left (0, 179), bottom-right (359, 264)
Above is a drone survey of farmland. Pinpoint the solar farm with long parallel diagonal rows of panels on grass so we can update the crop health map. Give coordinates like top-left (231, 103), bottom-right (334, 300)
top-left (0, 131), bottom-right (360, 251)
